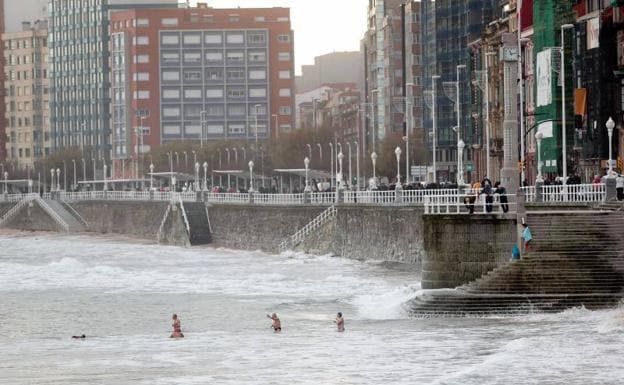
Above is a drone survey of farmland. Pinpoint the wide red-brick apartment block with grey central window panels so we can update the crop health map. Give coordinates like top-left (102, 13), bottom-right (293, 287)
top-left (111, 4), bottom-right (295, 164)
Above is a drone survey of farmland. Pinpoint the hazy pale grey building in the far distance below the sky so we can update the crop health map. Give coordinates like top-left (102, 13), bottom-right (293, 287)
top-left (295, 51), bottom-right (364, 94)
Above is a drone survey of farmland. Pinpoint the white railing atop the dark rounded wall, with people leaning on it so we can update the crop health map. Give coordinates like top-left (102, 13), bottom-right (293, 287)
top-left (425, 193), bottom-right (517, 215)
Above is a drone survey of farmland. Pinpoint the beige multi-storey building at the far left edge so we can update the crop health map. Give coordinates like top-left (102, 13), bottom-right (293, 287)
top-left (2, 21), bottom-right (50, 167)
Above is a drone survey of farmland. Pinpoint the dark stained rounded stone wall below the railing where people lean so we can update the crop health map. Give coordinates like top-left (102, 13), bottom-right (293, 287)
top-left (421, 215), bottom-right (516, 289)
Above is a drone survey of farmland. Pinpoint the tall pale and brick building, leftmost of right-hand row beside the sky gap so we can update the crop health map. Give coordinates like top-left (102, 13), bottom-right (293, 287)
top-left (362, 0), bottom-right (423, 156)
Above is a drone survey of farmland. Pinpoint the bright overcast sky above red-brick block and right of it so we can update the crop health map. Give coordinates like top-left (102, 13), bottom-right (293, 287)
top-left (191, 0), bottom-right (368, 73)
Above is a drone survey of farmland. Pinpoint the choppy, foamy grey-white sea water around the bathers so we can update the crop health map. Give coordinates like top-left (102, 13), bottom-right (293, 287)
top-left (0, 234), bottom-right (624, 385)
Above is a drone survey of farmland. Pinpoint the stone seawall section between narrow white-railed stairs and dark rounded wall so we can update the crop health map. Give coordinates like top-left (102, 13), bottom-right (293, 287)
top-left (300, 205), bottom-right (424, 264)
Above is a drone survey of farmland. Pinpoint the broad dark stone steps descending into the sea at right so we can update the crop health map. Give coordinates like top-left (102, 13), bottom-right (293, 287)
top-left (411, 211), bottom-right (624, 317)
